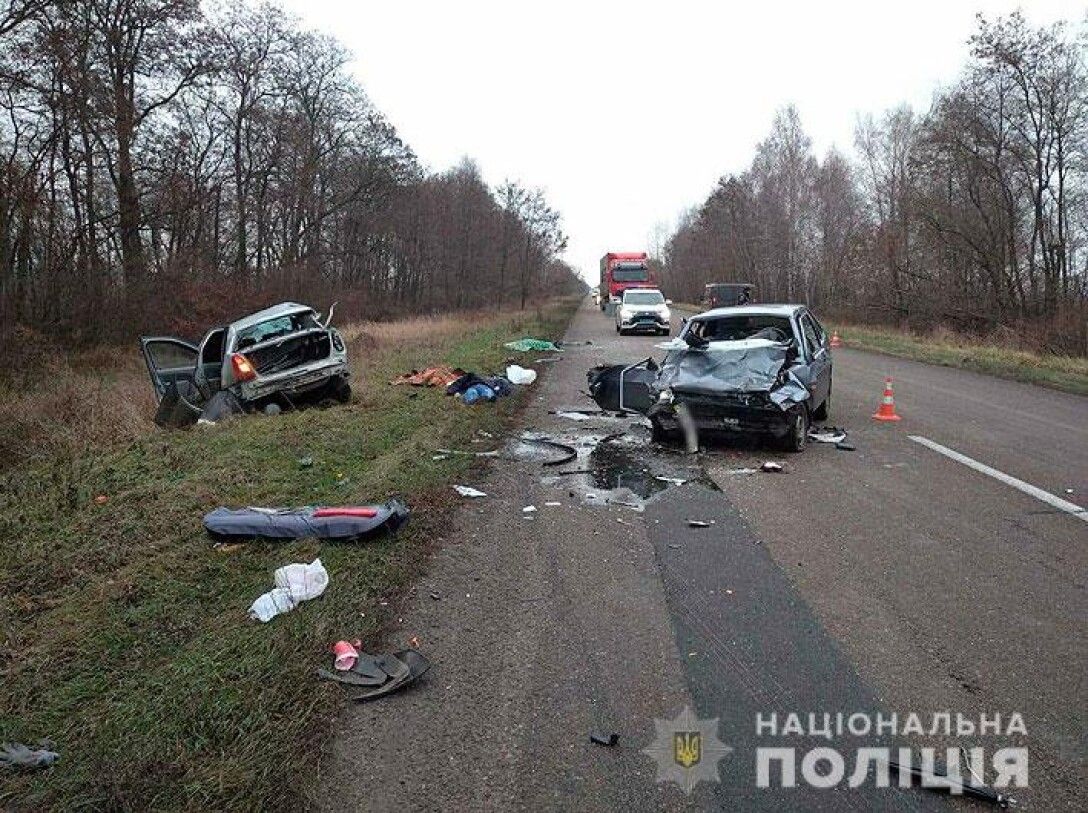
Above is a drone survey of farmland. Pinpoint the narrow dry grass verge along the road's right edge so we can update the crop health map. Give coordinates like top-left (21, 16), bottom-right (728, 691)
top-left (827, 322), bottom-right (1088, 395)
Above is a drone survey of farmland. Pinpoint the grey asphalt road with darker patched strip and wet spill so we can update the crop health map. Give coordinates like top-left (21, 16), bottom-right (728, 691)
top-left (312, 306), bottom-right (1088, 811)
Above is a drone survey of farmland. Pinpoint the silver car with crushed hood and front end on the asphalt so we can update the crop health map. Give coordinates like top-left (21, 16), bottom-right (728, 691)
top-left (588, 305), bottom-right (831, 452)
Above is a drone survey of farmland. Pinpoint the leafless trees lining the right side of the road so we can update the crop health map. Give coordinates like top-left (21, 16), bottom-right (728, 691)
top-left (662, 14), bottom-right (1088, 354)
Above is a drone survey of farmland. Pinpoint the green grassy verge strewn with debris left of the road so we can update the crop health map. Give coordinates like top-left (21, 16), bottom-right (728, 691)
top-left (0, 303), bottom-right (574, 810)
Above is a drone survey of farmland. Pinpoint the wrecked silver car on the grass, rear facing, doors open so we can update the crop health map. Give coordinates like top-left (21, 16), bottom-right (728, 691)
top-left (140, 303), bottom-right (351, 427)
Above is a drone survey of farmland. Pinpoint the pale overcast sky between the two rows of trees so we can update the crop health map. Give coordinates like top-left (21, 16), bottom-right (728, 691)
top-left (283, 0), bottom-right (1088, 280)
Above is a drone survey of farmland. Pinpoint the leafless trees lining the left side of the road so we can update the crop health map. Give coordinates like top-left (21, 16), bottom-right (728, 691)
top-left (0, 0), bottom-right (579, 343)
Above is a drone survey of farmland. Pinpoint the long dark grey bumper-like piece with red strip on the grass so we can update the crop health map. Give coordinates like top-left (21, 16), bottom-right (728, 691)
top-left (203, 500), bottom-right (408, 541)
